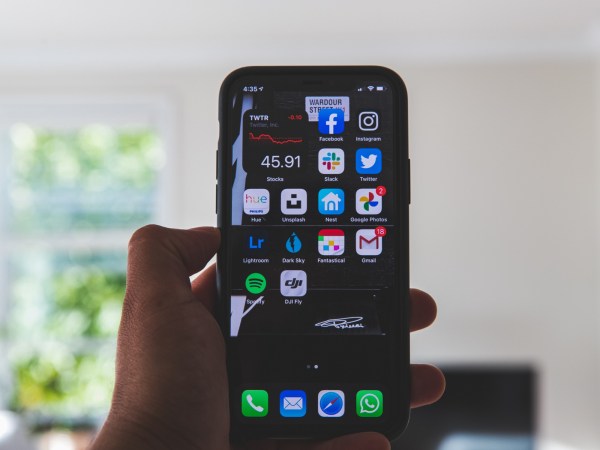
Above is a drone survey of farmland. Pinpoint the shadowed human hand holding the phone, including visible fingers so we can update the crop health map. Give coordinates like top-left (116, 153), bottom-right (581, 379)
top-left (91, 225), bottom-right (445, 450)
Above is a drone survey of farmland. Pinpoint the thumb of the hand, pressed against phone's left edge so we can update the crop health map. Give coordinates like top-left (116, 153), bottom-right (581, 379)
top-left (125, 225), bottom-right (220, 306)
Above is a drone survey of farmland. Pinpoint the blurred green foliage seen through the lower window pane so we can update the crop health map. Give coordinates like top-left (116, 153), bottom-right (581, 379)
top-left (8, 253), bottom-right (125, 424)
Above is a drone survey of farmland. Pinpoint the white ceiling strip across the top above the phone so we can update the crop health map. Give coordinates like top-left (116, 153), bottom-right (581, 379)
top-left (0, 0), bottom-right (600, 67)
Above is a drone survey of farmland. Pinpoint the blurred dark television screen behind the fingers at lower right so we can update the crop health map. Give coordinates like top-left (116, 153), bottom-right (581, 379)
top-left (392, 366), bottom-right (536, 450)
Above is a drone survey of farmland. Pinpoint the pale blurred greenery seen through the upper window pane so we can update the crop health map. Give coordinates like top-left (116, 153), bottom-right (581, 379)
top-left (7, 124), bottom-right (164, 235)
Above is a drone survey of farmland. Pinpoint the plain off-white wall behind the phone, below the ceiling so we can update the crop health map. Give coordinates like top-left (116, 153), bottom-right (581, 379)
top-left (0, 61), bottom-right (600, 450)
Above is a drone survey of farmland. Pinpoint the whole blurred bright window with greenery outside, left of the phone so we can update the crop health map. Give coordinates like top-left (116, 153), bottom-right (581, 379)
top-left (0, 99), bottom-right (165, 427)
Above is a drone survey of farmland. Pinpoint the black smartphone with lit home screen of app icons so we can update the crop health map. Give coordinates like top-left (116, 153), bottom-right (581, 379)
top-left (217, 66), bottom-right (410, 440)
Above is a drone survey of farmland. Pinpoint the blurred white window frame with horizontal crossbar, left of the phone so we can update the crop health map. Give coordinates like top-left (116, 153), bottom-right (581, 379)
top-left (0, 93), bottom-right (177, 409)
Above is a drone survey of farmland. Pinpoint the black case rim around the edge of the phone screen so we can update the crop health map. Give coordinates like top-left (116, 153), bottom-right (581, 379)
top-left (216, 66), bottom-right (410, 442)
